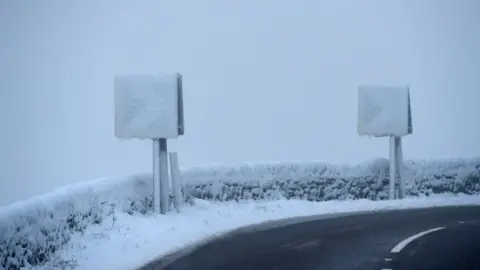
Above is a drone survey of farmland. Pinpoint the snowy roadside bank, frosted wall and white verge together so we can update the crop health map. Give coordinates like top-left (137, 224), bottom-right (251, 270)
top-left (0, 158), bottom-right (480, 270)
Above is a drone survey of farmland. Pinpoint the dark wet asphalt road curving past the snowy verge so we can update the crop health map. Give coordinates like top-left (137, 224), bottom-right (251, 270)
top-left (141, 206), bottom-right (480, 270)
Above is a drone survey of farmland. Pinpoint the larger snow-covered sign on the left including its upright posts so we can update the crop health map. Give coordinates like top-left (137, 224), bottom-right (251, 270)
top-left (114, 73), bottom-right (185, 214)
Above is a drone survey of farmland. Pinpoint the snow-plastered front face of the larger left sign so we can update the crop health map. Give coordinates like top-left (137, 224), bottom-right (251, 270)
top-left (115, 74), bottom-right (178, 139)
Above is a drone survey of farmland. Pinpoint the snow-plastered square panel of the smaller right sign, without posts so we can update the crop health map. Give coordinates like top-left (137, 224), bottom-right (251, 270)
top-left (358, 86), bottom-right (410, 137)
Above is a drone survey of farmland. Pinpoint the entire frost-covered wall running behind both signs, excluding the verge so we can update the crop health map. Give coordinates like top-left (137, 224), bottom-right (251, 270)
top-left (0, 158), bottom-right (480, 269)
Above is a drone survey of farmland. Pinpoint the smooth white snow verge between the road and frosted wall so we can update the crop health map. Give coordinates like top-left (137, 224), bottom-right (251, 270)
top-left (34, 194), bottom-right (480, 270)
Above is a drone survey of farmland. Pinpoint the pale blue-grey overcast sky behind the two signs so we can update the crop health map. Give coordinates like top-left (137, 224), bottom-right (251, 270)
top-left (0, 0), bottom-right (480, 205)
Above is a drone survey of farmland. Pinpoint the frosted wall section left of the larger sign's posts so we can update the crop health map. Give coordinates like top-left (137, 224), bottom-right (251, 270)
top-left (0, 175), bottom-right (151, 270)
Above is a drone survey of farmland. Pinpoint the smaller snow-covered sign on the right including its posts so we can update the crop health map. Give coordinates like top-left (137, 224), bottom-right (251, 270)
top-left (357, 86), bottom-right (413, 200)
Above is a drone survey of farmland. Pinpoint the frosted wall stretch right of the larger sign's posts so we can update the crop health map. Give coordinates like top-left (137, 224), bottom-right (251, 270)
top-left (184, 158), bottom-right (480, 201)
